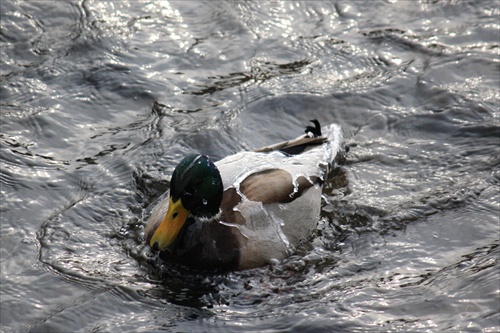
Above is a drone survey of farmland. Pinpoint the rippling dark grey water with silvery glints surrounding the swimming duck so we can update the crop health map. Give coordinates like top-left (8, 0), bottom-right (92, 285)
top-left (0, 0), bottom-right (500, 332)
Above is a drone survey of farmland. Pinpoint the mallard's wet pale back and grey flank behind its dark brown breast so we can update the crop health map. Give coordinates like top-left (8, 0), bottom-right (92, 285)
top-left (216, 124), bottom-right (343, 269)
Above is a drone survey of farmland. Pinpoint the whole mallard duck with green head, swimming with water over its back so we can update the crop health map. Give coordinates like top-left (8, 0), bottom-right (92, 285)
top-left (145, 120), bottom-right (343, 270)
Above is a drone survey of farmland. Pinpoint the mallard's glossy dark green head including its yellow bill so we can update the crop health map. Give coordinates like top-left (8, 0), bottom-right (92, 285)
top-left (149, 155), bottom-right (223, 250)
